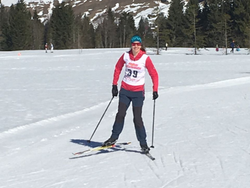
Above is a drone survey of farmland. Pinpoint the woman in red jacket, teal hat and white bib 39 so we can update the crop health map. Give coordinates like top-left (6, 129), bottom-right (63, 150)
top-left (103, 35), bottom-right (158, 153)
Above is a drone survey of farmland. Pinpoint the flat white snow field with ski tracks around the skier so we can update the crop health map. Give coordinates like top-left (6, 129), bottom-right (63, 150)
top-left (0, 48), bottom-right (250, 188)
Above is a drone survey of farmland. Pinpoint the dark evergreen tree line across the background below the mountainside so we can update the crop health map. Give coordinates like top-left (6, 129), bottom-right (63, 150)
top-left (0, 0), bottom-right (250, 50)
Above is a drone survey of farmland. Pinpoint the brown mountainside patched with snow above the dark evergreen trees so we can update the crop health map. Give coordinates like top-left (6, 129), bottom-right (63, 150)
top-left (2, 0), bottom-right (171, 26)
